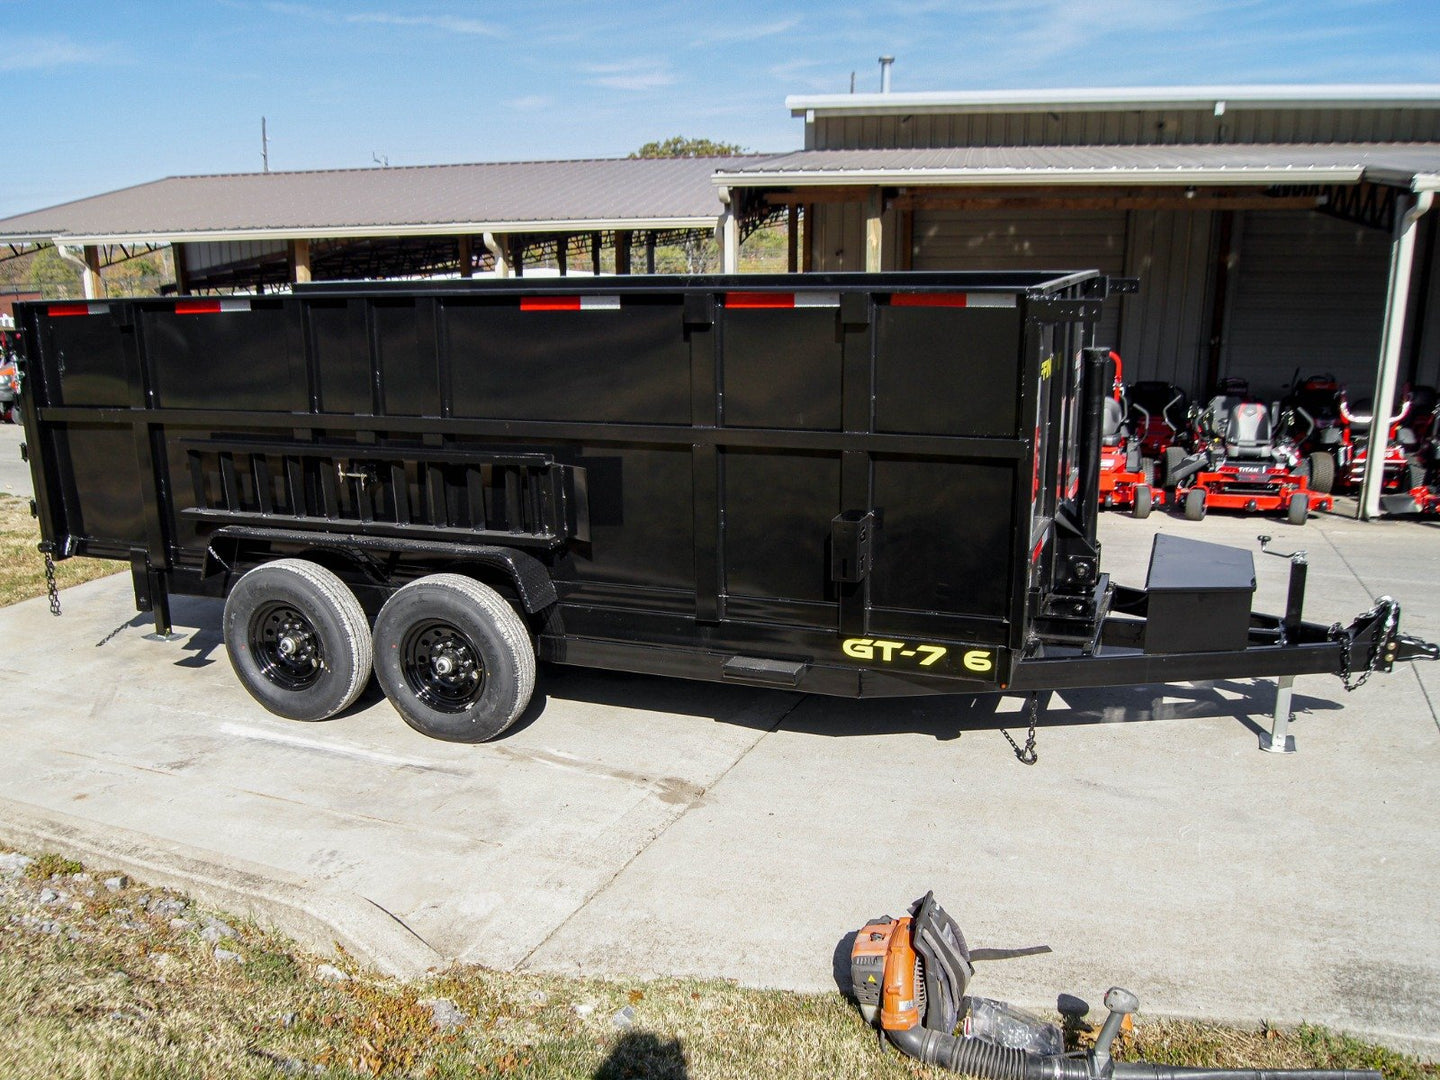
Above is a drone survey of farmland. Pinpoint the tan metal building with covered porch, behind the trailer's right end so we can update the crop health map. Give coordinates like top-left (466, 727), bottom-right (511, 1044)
top-left (716, 86), bottom-right (1440, 515)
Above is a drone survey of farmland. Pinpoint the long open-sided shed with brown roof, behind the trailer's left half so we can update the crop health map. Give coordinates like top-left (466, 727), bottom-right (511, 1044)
top-left (0, 157), bottom-right (747, 292)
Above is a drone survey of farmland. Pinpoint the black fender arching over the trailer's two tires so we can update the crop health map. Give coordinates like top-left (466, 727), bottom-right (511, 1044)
top-left (204, 526), bottom-right (560, 615)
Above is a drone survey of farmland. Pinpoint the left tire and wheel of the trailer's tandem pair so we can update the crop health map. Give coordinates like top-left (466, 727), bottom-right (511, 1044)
top-left (222, 559), bottom-right (372, 720)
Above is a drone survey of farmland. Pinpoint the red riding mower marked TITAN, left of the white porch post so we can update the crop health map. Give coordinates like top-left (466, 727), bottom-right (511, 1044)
top-left (1168, 379), bottom-right (1333, 526)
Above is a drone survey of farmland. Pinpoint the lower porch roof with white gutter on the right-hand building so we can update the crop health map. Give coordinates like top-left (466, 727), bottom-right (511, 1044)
top-left (714, 143), bottom-right (1440, 190)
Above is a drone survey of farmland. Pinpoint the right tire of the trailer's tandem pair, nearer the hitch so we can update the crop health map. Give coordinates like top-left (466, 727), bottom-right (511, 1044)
top-left (374, 573), bottom-right (536, 743)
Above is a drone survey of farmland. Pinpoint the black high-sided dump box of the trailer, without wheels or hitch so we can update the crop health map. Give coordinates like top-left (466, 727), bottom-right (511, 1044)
top-left (20, 274), bottom-right (1103, 694)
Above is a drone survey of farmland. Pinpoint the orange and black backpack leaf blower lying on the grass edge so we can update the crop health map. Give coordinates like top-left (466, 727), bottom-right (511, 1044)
top-left (850, 893), bottom-right (1380, 1080)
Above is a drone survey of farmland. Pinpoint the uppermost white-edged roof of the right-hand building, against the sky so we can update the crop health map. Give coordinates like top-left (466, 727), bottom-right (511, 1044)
top-left (785, 82), bottom-right (1440, 117)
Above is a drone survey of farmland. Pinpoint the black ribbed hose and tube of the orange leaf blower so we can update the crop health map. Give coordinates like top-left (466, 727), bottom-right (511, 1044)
top-left (886, 1027), bottom-right (1381, 1080)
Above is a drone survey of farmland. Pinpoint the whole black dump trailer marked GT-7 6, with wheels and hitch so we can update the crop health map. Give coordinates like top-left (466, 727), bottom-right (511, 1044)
top-left (8, 272), bottom-right (1434, 742)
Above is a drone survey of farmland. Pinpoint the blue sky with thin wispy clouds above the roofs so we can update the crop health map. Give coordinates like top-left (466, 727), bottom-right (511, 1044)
top-left (0, 0), bottom-right (1440, 216)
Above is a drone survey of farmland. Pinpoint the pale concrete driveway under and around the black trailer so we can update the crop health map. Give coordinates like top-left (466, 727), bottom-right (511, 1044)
top-left (0, 514), bottom-right (1440, 1054)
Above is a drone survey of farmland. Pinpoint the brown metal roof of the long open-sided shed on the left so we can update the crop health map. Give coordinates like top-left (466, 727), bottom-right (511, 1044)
top-left (0, 157), bottom-right (757, 243)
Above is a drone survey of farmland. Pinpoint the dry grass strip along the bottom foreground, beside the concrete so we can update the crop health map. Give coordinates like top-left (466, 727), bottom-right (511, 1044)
top-left (0, 855), bottom-right (1440, 1080)
